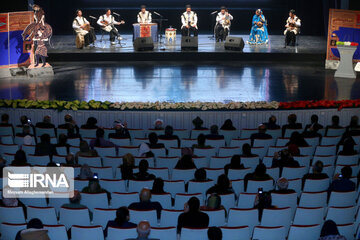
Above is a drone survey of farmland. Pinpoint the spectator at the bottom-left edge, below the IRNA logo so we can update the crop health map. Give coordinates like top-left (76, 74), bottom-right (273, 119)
top-left (15, 218), bottom-right (50, 240)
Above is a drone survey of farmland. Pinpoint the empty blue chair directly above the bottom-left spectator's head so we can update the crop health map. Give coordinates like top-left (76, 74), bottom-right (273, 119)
top-left (26, 206), bottom-right (57, 225)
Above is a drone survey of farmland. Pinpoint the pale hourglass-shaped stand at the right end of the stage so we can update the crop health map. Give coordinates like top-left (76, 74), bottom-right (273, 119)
top-left (335, 45), bottom-right (357, 78)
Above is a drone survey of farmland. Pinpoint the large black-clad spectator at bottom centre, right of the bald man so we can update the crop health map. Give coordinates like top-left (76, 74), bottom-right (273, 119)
top-left (177, 197), bottom-right (209, 233)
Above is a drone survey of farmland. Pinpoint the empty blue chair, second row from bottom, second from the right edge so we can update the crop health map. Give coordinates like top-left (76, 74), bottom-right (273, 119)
top-left (293, 207), bottom-right (325, 226)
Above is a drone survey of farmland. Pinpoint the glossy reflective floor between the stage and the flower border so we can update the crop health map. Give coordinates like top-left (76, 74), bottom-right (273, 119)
top-left (0, 61), bottom-right (360, 102)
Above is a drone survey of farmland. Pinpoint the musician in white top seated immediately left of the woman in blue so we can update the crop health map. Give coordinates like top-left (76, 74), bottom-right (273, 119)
top-left (215, 7), bottom-right (234, 42)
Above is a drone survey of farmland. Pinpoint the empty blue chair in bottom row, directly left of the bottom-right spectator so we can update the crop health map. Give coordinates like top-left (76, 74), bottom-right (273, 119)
top-left (288, 224), bottom-right (321, 240)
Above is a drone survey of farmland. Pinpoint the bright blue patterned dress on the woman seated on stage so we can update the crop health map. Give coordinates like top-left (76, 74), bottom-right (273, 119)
top-left (248, 14), bottom-right (269, 44)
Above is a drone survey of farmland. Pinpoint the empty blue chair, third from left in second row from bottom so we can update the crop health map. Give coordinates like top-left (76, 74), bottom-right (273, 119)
top-left (59, 207), bottom-right (90, 229)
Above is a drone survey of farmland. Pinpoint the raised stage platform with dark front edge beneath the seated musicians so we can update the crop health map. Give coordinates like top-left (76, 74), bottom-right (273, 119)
top-left (49, 33), bottom-right (326, 64)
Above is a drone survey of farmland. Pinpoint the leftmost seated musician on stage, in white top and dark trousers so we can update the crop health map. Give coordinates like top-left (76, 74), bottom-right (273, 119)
top-left (73, 9), bottom-right (96, 47)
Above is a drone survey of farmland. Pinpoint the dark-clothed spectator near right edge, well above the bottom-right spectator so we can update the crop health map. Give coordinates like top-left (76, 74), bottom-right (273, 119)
top-left (328, 166), bottom-right (356, 194)
